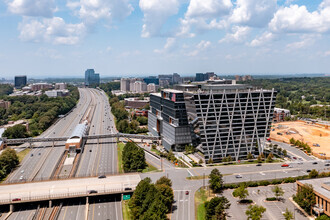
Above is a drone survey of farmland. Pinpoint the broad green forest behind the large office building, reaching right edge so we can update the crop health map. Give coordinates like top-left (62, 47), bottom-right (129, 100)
top-left (248, 77), bottom-right (330, 120)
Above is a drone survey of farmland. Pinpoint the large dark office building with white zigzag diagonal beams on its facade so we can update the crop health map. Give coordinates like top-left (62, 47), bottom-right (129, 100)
top-left (148, 80), bottom-right (276, 162)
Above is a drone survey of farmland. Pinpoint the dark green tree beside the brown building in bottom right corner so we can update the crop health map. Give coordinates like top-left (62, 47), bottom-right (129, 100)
top-left (293, 184), bottom-right (316, 213)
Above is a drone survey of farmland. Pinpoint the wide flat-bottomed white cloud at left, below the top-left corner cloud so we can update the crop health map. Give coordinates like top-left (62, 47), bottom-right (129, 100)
top-left (19, 17), bottom-right (86, 45)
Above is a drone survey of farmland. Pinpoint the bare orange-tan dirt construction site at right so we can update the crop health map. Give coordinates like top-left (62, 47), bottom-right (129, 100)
top-left (270, 121), bottom-right (330, 158)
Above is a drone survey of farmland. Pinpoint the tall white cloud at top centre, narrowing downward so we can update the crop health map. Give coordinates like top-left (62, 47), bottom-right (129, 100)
top-left (139, 0), bottom-right (180, 37)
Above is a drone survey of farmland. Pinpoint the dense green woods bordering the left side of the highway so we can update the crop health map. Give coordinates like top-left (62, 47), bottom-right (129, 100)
top-left (0, 86), bottom-right (79, 138)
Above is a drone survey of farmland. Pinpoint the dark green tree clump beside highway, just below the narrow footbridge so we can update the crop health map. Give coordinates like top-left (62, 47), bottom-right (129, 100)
top-left (122, 142), bottom-right (147, 172)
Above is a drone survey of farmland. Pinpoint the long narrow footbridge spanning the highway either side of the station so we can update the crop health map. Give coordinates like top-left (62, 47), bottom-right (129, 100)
top-left (2, 133), bottom-right (160, 145)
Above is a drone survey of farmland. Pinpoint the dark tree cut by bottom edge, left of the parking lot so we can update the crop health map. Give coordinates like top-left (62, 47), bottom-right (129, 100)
top-left (204, 196), bottom-right (230, 220)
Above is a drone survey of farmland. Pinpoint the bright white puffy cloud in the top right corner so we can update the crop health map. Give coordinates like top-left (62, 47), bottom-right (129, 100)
top-left (269, 1), bottom-right (330, 33)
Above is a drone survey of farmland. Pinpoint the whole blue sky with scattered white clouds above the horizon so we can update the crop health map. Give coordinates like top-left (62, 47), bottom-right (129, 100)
top-left (0, 0), bottom-right (330, 78)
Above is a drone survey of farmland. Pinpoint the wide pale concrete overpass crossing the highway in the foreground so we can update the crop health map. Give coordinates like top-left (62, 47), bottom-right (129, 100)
top-left (0, 174), bottom-right (141, 206)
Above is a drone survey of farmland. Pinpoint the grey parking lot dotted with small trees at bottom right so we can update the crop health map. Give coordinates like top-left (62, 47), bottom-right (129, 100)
top-left (223, 183), bottom-right (308, 220)
